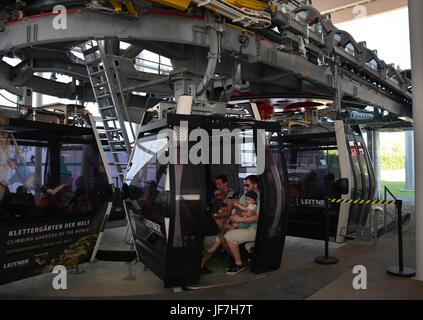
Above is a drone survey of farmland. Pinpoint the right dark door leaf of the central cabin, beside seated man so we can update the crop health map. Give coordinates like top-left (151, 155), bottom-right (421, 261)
top-left (253, 132), bottom-right (288, 273)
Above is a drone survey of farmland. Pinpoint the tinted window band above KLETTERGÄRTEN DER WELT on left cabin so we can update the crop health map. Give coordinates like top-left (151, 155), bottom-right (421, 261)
top-left (0, 135), bottom-right (108, 218)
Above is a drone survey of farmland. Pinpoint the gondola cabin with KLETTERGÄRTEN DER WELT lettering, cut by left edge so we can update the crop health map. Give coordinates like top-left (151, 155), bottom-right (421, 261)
top-left (0, 109), bottom-right (113, 284)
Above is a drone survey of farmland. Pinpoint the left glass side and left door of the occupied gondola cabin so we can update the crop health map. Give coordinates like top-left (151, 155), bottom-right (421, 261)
top-left (125, 127), bottom-right (206, 288)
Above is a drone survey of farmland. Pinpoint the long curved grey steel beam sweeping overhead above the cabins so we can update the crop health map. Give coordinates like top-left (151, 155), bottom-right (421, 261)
top-left (0, 12), bottom-right (411, 116)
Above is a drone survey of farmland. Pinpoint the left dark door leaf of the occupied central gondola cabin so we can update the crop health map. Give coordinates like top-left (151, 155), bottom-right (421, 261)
top-left (164, 164), bottom-right (206, 288)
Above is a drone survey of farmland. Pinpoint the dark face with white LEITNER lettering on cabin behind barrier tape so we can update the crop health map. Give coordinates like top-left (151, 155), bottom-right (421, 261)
top-left (284, 135), bottom-right (341, 239)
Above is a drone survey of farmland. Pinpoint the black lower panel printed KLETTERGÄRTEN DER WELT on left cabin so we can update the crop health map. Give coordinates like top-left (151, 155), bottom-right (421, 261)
top-left (0, 213), bottom-right (104, 284)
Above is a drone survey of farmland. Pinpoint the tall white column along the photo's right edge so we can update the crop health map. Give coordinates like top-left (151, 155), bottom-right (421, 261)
top-left (408, 0), bottom-right (423, 281)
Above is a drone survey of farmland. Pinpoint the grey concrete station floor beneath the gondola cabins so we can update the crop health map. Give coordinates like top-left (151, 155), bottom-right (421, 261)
top-left (0, 221), bottom-right (423, 300)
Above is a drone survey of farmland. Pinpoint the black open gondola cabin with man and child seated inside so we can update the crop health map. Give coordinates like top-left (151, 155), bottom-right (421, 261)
top-left (124, 114), bottom-right (288, 287)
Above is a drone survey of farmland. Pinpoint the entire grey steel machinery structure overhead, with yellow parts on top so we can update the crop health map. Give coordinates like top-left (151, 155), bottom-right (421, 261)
top-left (0, 0), bottom-right (412, 127)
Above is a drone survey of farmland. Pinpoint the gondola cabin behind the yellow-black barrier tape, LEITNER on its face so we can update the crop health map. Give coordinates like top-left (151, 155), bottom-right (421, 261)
top-left (283, 121), bottom-right (376, 242)
